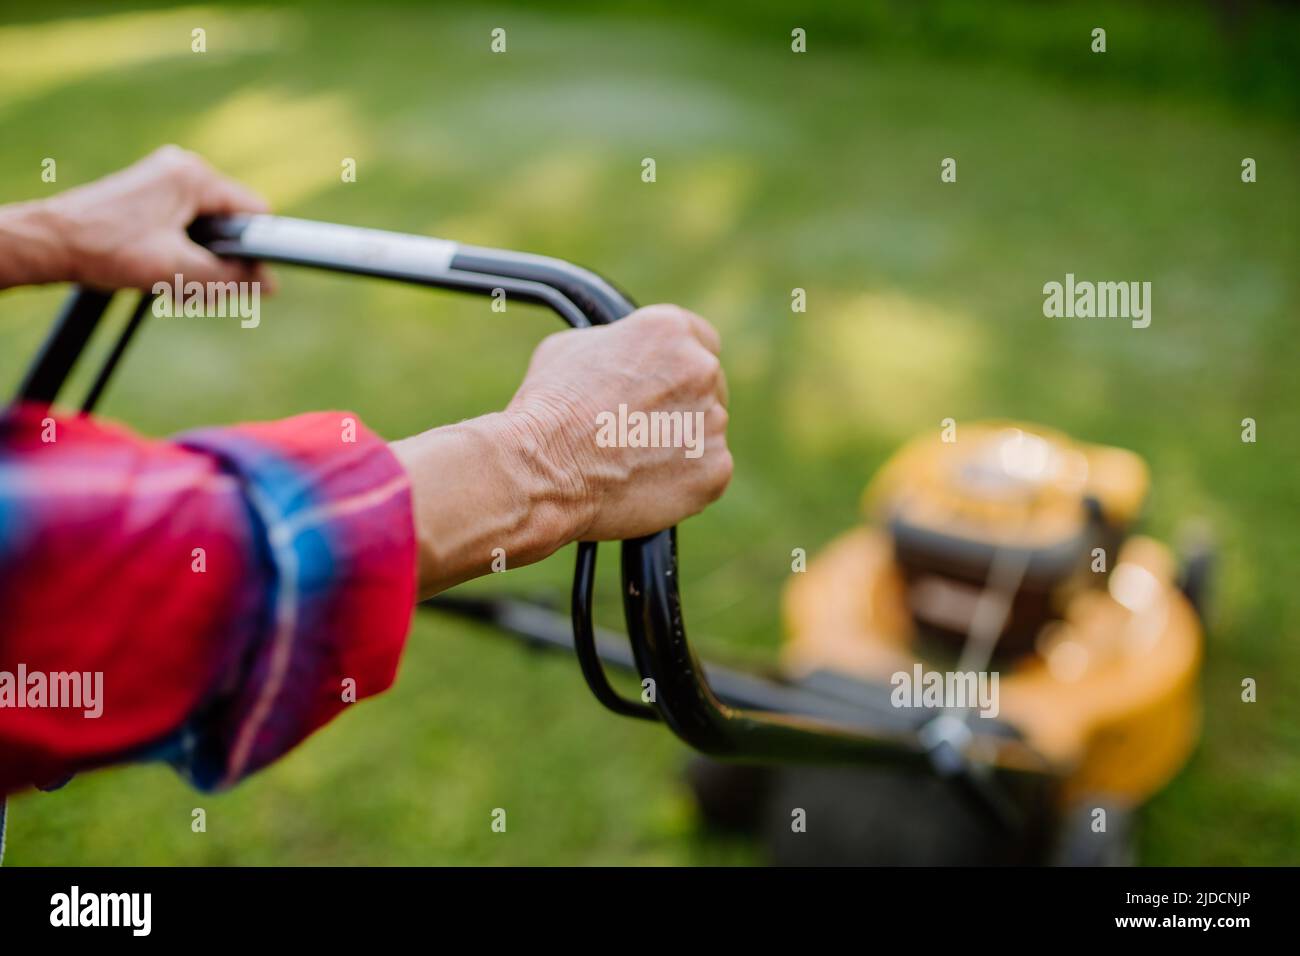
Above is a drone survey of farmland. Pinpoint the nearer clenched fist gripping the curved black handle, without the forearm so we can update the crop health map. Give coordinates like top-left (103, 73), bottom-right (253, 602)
top-left (506, 306), bottom-right (732, 541)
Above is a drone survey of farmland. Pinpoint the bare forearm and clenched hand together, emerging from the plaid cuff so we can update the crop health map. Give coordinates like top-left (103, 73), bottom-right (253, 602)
top-left (391, 306), bottom-right (732, 597)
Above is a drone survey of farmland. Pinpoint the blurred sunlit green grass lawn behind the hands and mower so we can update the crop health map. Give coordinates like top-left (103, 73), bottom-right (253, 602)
top-left (0, 4), bottom-right (1300, 864)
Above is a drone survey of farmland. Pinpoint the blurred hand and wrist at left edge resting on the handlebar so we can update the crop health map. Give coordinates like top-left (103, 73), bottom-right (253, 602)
top-left (0, 146), bottom-right (272, 291)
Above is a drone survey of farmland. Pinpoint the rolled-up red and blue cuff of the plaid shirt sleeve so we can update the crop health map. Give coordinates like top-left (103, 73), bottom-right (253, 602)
top-left (174, 412), bottom-right (416, 790)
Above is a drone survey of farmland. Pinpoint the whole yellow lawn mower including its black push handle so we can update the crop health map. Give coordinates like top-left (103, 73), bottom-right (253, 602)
top-left (18, 216), bottom-right (1209, 864)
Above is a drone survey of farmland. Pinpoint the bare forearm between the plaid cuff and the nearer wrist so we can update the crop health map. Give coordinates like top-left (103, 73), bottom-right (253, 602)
top-left (390, 412), bottom-right (590, 598)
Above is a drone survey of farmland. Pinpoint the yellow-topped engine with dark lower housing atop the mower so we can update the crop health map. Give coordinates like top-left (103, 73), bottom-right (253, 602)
top-left (867, 424), bottom-right (1148, 658)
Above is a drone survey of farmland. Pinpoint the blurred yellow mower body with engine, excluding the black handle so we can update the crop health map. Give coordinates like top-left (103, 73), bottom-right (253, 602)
top-left (783, 423), bottom-right (1201, 804)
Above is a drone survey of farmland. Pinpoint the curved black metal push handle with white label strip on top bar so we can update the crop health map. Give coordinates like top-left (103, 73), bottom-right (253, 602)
top-left (12, 216), bottom-right (1043, 822)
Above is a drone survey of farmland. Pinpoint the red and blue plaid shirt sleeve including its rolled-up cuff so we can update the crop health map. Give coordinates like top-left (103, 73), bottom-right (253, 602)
top-left (0, 406), bottom-right (416, 793)
